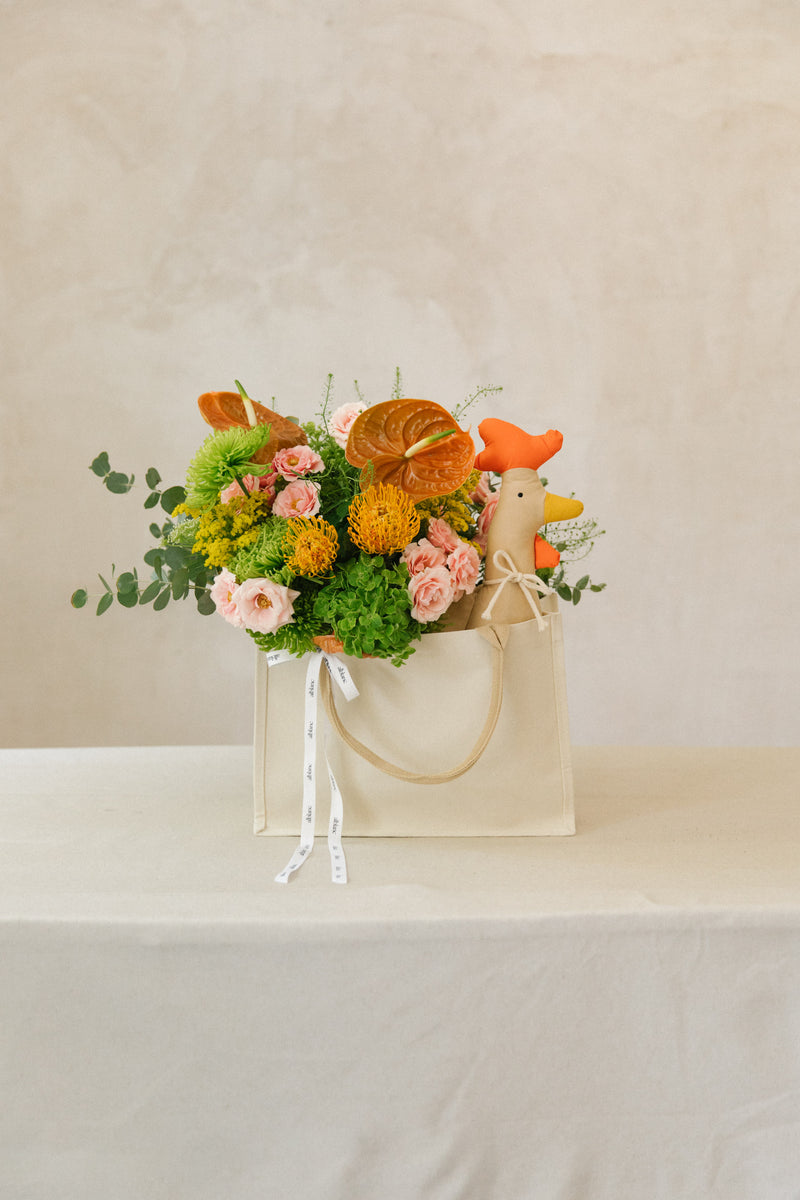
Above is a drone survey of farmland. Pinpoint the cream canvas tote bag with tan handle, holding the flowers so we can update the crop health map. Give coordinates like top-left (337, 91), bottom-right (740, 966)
top-left (253, 596), bottom-right (575, 838)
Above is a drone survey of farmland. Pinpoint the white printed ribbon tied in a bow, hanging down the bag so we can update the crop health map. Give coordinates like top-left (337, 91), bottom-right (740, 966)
top-left (266, 650), bottom-right (359, 883)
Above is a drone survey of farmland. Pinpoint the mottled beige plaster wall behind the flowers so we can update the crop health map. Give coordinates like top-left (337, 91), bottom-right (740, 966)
top-left (0, 0), bottom-right (800, 745)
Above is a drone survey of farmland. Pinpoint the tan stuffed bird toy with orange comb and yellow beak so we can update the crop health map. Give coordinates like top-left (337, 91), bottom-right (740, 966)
top-left (467, 418), bottom-right (583, 629)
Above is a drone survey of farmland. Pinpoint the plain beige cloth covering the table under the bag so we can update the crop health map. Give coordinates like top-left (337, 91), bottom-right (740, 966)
top-left (0, 748), bottom-right (800, 1200)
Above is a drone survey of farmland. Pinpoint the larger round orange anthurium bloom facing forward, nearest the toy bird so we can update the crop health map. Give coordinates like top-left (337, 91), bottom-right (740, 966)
top-left (344, 400), bottom-right (475, 502)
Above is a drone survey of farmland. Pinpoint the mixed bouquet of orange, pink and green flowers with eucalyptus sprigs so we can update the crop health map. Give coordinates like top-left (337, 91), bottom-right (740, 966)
top-left (72, 372), bottom-right (604, 666)
